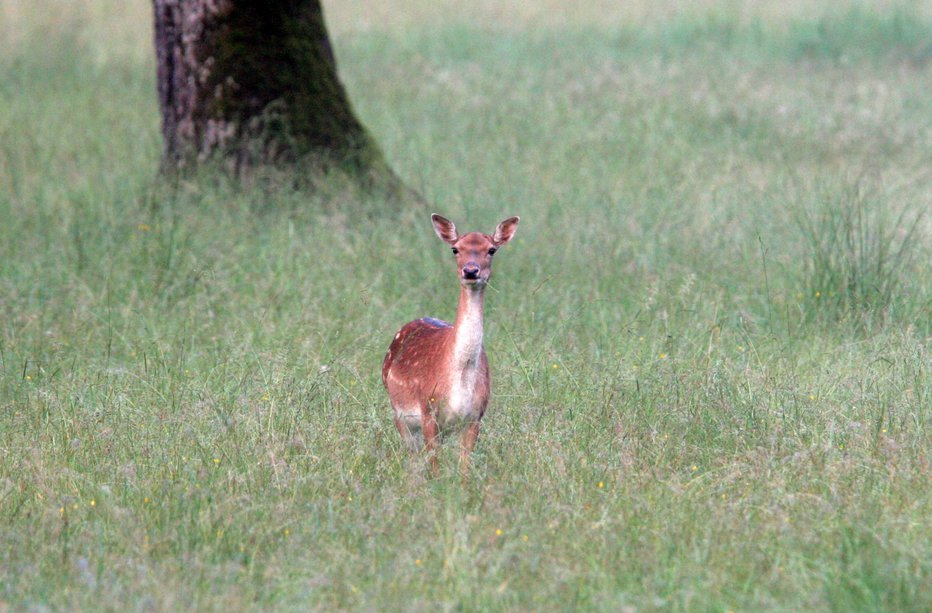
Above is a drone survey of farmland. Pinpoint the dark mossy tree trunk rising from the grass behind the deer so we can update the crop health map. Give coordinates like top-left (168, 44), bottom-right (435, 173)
top-left (153, 0), bottom-right (412, 192)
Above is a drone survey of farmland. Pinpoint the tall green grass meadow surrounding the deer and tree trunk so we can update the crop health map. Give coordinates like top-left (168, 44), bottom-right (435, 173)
top-left (0, 0), bottom-right (932, 612)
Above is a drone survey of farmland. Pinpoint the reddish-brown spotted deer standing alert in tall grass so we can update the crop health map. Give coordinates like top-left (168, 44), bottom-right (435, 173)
top-left (382, 213), bottom-right (520, 478)
